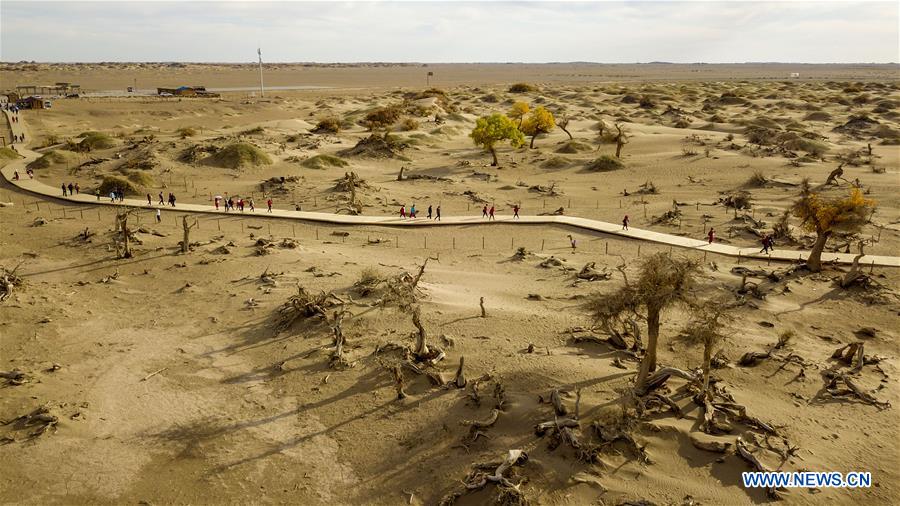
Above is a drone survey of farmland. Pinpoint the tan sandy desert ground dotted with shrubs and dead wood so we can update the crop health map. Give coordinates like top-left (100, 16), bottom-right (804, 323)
top-left (0, 66), bottom-right (900, 505)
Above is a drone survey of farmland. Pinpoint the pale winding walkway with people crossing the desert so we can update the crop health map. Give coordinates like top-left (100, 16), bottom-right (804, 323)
top-left (0, 111), bottom-right (900, 267)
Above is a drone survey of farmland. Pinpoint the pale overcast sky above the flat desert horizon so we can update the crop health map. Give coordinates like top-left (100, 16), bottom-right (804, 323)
top-left (0, 0), bottom-right (900, 63)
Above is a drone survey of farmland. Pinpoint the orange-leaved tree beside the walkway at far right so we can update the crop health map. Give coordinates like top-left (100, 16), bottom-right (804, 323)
top-left (791, 179), bottom-right (875, 272)
